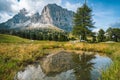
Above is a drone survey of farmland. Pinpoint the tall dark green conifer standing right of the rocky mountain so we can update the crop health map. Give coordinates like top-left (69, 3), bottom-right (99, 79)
top-left (73, 1), bottom-right (94, 40)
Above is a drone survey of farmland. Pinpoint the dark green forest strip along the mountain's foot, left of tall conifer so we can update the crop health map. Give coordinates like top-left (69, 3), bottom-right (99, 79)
top-left (0, 29), bottom-right (69, 41)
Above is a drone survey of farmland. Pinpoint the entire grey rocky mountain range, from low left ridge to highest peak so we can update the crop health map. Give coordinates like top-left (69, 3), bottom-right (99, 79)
top-left (0, 4), bottom-right (74, 31)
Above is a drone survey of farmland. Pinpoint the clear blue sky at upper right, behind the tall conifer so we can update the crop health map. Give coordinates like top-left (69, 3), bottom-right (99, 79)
top-left (62, 0), bottom-right (120, 30)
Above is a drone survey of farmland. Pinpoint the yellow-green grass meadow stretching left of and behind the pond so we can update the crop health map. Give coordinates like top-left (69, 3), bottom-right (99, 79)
top-left (0, 41), bottom-right (120, 80)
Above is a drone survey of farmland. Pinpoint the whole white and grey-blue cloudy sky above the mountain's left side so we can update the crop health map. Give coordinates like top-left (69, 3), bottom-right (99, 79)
top-left (0, 0), bottom-right (62, 23)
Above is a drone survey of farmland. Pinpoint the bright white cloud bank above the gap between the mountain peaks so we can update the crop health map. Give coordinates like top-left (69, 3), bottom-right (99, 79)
top-left (13, 0), bottom-right (61, 12)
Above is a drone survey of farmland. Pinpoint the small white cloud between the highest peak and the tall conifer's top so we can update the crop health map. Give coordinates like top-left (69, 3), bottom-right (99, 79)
top-left (64, 2), bottom-right (81, 12)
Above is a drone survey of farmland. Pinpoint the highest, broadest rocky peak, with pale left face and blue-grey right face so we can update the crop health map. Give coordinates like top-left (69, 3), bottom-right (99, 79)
top-left (41, 4), bottom-right (74, 31)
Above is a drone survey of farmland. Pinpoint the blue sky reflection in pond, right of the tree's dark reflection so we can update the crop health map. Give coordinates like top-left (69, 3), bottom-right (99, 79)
top-left (91, 54), bottom-right (112, 80)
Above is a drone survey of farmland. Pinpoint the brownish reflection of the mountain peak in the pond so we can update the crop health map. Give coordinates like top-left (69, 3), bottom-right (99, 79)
top-left (41, 51), bottom-right (74, 75)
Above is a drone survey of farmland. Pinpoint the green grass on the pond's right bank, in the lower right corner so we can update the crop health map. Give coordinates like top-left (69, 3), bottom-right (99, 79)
top-left (102, 48), bottom-right (120, 80)
